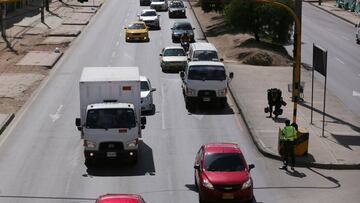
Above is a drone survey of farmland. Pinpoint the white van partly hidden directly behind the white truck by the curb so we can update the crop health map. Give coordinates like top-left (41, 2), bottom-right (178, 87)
top-left (188, 42), bottom-right (223, 61)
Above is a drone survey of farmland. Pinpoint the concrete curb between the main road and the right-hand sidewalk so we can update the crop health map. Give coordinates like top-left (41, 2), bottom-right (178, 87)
top-left (188, 0), bottom-right (360, 170)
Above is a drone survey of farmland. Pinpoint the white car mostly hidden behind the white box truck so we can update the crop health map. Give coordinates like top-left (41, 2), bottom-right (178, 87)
top-left (140, 76), bottom-right (156, 115)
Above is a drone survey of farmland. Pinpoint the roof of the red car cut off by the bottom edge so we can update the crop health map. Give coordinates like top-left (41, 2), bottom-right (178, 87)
top-left (96, 194), bottom-right (145, 203)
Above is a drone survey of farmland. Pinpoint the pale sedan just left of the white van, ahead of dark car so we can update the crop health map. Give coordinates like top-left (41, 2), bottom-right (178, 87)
top-left (160, 46), bottom-right (187, 72)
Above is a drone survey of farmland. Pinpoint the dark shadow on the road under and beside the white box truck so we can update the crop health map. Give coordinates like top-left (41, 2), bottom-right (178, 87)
top-left (84, 142), bottom-right (155, 177)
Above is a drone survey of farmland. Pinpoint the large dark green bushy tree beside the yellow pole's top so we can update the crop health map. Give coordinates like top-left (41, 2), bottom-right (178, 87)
top-left (224, 0), bottom-right (294, 42)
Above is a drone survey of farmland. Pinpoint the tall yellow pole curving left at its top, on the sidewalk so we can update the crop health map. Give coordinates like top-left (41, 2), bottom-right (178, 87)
top-left (254, 0), bottom-right (301, 123)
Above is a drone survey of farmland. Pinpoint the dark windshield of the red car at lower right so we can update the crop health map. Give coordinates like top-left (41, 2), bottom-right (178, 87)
top-left (205, 153), bottom-right (245, 172)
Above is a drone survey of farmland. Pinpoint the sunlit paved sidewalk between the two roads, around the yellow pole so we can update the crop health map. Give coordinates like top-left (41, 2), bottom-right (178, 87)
top-left (188, 1), bottom-right (360, 169)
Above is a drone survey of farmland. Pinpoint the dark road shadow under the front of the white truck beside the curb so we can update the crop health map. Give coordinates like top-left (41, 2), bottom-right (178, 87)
top-left (188, 103), bottom-right (234, 115)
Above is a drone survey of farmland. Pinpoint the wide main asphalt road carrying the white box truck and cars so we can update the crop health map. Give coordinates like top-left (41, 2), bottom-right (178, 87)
top-left (0, 0), bottom-right (360, 203)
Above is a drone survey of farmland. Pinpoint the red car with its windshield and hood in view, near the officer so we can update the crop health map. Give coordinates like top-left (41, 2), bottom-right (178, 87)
top-left (194, 143), bottom-right (255, 203)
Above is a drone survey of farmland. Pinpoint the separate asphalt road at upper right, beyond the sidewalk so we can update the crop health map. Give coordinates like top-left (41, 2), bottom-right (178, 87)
top-left (292, 3), bottom-right (360, 116)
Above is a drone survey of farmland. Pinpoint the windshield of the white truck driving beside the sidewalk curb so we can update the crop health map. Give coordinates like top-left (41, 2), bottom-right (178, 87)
top-left (188, 66), bottom-right (226, 80)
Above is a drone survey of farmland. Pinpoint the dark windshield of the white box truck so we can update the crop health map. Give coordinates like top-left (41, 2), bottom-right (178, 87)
top-left (86, 109), bottom-right (136, 129)
